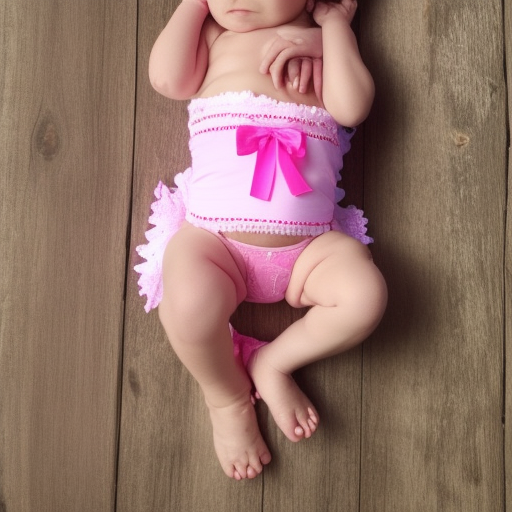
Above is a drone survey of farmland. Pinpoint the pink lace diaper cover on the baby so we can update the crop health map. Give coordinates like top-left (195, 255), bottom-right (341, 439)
top-left (219, 235), bottom-right (313, 304)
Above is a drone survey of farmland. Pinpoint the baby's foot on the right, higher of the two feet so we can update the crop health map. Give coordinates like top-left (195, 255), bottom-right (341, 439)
top-left (247, 350), bottom-right (318, 442)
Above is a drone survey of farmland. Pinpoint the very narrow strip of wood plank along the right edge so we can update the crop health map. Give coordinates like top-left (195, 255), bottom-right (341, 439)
top-left (504, 0), bottom-right (512, 510)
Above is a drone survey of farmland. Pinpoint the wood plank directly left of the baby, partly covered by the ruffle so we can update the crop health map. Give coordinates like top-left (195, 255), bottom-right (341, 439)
top-left (117, 0), bottom-right (261, 512)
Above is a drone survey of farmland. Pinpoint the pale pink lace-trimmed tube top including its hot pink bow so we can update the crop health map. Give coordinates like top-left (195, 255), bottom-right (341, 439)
top-left (185, 92), bottom-right (352, 236)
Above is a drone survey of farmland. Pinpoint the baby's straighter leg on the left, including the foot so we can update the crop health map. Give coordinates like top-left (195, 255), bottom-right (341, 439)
top-left (159, 225), bottom-right (271, 479)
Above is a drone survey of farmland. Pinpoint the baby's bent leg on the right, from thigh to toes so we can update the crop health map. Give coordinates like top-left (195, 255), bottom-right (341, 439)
top-left (249, 232), bottom-right (387, 441)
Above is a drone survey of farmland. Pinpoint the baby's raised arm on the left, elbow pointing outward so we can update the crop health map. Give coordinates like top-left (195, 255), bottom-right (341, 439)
top-left (149, 0), bottom-right (220, 100)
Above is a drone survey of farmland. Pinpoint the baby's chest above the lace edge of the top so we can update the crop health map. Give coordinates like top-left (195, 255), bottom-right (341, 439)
top-left (196, 28), bottom-right (320, 106)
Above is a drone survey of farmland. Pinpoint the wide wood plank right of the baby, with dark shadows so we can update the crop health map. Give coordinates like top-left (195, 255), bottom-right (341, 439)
top-left (361, 0), bottom-right (506, 512)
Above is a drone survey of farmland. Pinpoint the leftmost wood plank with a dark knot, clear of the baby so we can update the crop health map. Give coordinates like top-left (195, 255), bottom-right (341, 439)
top-left (0, 0), bottom-right (136, 512)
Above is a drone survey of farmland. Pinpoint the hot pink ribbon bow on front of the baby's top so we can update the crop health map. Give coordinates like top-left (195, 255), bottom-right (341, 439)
top-left (236, 126), bottom-right (312, 201)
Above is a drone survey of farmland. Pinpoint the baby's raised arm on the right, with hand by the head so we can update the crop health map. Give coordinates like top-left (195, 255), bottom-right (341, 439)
top-left (313, 0), bottom-right (375, 126)
